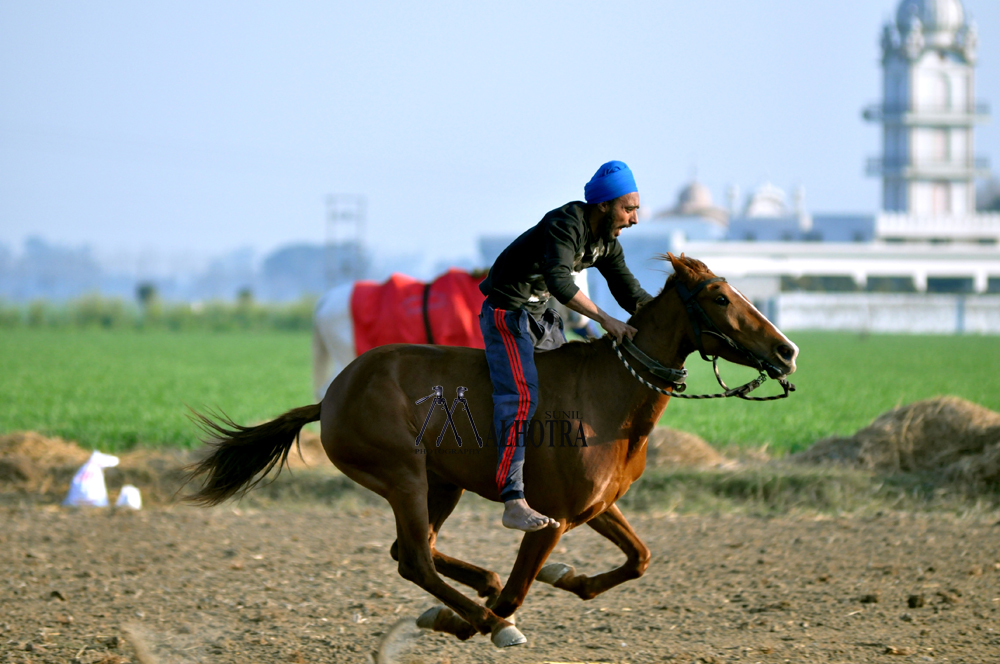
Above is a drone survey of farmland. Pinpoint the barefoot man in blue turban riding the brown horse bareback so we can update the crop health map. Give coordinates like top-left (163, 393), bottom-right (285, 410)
top-left (479, 161), bottom-right (652, 532)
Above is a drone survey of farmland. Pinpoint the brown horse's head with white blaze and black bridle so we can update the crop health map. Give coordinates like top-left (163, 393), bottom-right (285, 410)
top-left (664, 253), bottom-right (799, 378)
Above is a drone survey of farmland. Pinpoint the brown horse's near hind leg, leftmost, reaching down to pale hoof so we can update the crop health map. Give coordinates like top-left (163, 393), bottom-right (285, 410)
top-left (387, 483), bottom-right (525, 646)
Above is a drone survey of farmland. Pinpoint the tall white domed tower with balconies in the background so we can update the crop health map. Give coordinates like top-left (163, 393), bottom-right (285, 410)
top-left (864, 0), bottom-right (989, 217)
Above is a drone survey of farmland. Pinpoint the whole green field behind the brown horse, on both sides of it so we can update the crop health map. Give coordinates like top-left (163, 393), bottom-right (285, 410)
top-left (0, 329), bottom-right (1000, 453)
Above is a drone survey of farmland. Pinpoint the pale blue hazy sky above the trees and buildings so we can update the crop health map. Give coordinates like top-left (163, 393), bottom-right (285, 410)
top-left (0, 0), bottom-right (1000, 268)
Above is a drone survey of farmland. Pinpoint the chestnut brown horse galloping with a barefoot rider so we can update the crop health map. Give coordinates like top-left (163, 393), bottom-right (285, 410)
top-left (191, 254), bottom-right (798, 646)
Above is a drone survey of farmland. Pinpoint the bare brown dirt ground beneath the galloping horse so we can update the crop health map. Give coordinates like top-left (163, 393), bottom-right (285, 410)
top-left (0, 501), bottom-right (1000, 664)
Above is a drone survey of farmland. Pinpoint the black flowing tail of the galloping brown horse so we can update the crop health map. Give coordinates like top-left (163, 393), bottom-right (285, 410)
top-left (184, 404), bottom-right (319, 505)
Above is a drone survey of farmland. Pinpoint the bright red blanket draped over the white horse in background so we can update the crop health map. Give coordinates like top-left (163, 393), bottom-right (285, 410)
top-left (351, 268), bottom-right (485, 355)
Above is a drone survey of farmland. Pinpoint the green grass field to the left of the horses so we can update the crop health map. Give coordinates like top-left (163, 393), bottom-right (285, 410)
top-left (0, 329), bottom-right (312, 451)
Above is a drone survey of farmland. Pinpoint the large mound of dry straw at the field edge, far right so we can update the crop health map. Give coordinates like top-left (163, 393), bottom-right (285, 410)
top-left (791, 396), bottom-right (1000, 487)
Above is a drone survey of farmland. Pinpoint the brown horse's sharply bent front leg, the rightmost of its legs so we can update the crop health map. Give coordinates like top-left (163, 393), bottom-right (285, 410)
top-left (538, 505), bottom-right (650, 599)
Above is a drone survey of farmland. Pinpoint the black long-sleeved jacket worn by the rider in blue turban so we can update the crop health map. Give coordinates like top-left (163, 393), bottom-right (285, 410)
top-left (479, 201), bottom-right (652, 317)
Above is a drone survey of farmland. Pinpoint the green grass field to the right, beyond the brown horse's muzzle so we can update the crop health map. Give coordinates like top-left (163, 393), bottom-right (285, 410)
top-left (660, 332), bottom-right (1000, 455)
